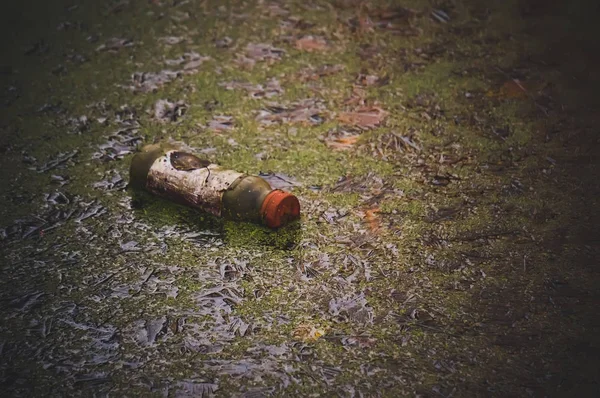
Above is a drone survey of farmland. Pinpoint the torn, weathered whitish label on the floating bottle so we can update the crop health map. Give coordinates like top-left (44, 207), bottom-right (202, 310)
top-left (146, 151), bottom-right (245, 216)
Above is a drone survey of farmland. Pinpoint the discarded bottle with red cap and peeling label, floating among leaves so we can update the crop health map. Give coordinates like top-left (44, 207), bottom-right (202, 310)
top-left (130, 144), bottom-right (300, 228)
